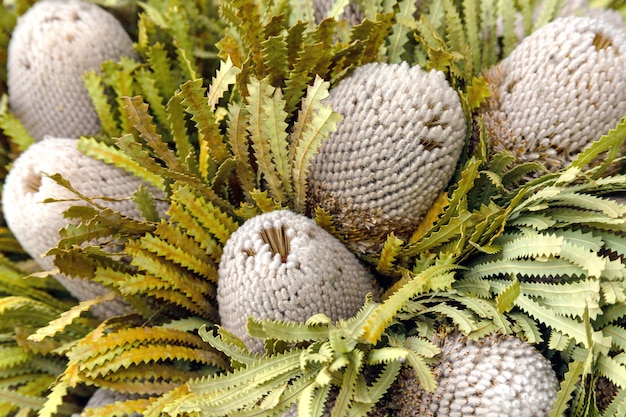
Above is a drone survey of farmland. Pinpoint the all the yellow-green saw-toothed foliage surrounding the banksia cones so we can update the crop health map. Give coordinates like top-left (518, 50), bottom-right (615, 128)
top-left (0, 0), bottom-right (626, 417)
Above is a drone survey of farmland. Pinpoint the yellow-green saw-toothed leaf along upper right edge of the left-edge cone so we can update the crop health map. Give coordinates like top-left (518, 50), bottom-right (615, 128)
top-left (76, 137), bottom-right (165, 190)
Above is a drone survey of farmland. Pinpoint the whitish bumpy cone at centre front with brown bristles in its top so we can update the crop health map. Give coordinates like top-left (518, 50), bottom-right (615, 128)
top-left (217, 210), bottom-right (375, 352)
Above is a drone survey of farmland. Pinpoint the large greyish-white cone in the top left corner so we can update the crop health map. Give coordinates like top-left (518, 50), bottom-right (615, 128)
top-left (7, 0), bottom-right (134, 140)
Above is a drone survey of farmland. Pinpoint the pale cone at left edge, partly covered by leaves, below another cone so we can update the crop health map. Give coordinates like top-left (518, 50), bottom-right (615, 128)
top-left (2, 137), bottom-right (166, 317)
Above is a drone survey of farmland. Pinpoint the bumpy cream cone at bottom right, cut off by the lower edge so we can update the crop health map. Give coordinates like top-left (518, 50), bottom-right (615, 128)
top-left (378, 334), bottom-right (559, 417)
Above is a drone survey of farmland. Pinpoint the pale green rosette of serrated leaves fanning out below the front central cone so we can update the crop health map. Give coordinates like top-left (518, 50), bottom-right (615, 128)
top-left (165, 301), bottom-right (438, 416)
